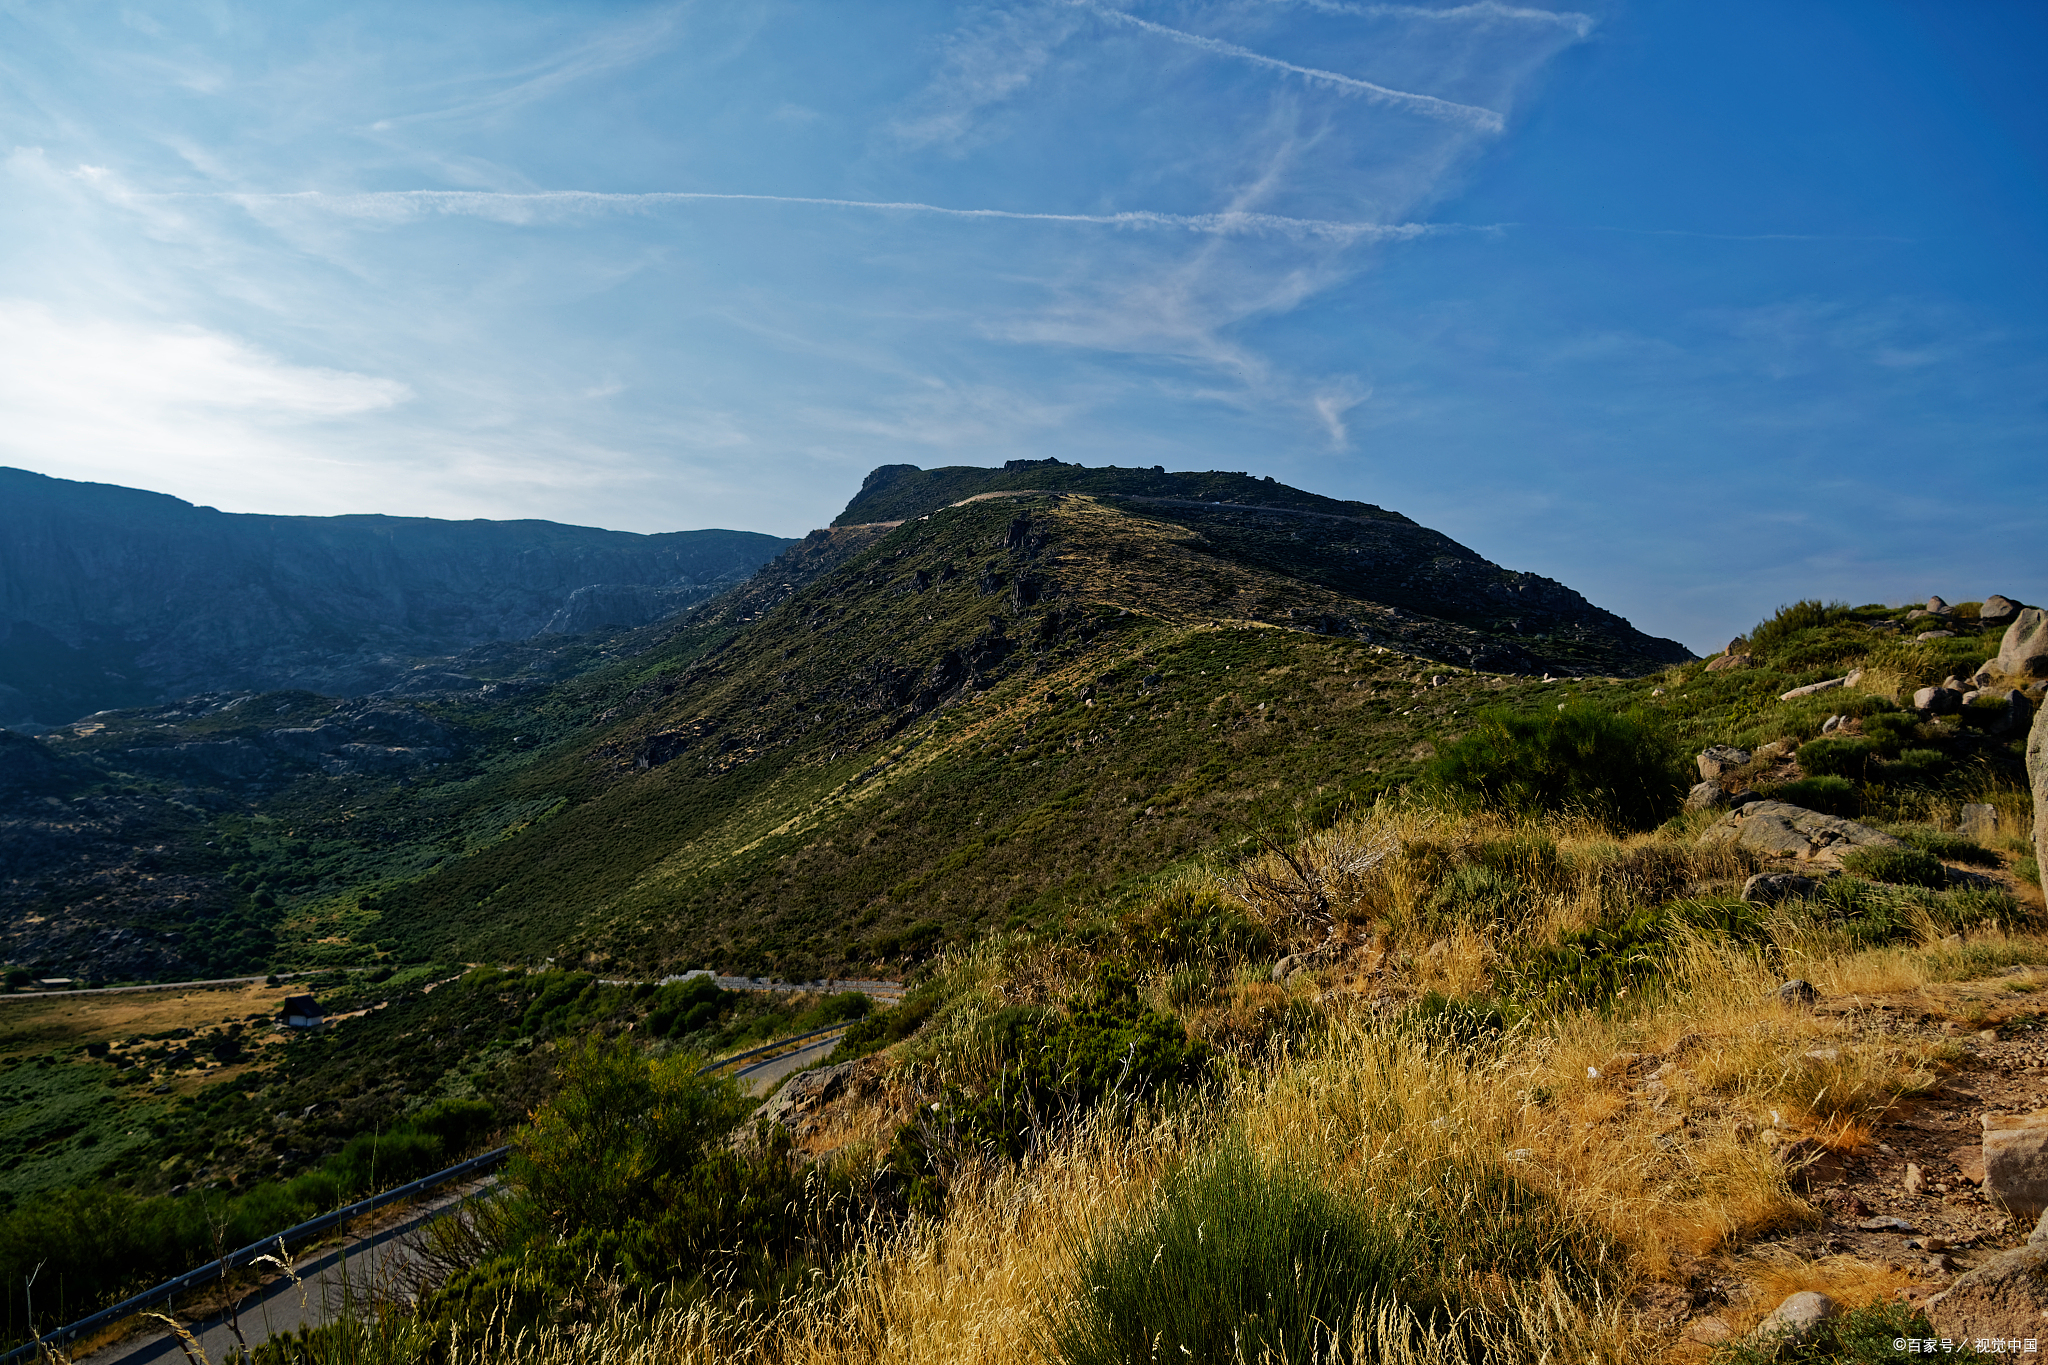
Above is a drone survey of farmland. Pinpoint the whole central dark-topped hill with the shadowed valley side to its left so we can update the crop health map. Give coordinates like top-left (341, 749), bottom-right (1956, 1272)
top-left (0, 465), bottom-right (1688, 976)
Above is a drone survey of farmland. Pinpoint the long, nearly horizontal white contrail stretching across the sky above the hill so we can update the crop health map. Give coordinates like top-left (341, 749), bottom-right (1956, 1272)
top-left (155, 190), bottom-right (1489, 244)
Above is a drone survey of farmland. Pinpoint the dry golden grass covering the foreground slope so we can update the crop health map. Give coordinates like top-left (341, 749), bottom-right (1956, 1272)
top-left (276, 806), bottom-right (2048, 1365)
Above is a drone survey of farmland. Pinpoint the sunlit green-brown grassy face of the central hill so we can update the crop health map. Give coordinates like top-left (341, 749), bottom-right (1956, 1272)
top-left (364, 497), bottom-right (1695, 972)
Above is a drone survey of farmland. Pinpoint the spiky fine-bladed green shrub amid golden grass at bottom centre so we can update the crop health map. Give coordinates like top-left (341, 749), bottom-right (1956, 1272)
top-left (1051, 1142), bottom-right (1434, 1365)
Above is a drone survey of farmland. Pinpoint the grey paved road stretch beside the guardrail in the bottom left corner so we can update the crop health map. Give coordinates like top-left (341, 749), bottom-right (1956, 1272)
top-left (78, 1177), bottom-right (498, 1365)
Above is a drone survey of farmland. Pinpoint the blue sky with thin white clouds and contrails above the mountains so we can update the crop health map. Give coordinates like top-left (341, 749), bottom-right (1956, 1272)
top-left (0, 0), bottom-right (2048, 651)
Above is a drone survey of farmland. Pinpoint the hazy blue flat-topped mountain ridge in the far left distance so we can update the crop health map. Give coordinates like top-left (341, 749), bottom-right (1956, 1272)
top-left (0, 469), bottom-right (791, 724)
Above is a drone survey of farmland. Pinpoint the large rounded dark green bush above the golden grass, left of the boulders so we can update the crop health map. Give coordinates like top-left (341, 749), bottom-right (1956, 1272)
top-left (1423, 706), bottom-right (1688, 829)
